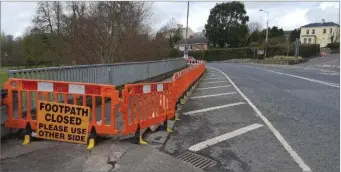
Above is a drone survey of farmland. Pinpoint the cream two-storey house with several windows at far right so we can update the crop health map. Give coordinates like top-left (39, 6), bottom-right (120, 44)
top-left (300, 19), bottom-right (340, 47)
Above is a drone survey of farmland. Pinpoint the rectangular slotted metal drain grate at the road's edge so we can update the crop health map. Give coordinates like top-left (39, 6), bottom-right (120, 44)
top-left (176, 151), bottom-right (218, 170)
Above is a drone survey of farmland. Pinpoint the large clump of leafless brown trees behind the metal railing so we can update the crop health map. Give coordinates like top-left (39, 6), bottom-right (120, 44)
top-left (12, 1), bottom-right (176, 64)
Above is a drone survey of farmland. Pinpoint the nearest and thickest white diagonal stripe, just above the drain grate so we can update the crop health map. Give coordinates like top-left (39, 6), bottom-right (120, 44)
top-left (189, 123), bottom-right (263, 152)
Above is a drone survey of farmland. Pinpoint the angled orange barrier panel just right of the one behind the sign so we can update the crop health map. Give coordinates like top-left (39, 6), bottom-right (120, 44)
top-left (120, 82), bottom-right (175, 135)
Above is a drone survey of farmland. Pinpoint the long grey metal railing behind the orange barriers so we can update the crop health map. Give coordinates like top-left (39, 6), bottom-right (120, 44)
top-left (8, 58), bottom-right (186, 86)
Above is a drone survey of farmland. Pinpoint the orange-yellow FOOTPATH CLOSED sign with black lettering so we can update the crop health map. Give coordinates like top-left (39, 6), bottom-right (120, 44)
top-left (37, 101), bottom-right (90, 144)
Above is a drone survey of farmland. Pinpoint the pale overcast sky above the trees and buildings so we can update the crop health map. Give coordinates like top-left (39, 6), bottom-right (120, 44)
top-left (1, 1), bottom-right (340, 37)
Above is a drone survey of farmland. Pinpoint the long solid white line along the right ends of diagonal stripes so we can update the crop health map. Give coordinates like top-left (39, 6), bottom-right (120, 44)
top-left (207, 66), bottom-right (311, 172)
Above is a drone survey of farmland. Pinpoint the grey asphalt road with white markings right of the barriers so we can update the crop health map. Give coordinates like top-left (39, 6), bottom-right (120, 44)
top-left (164, 56), bottom-right (340, 172)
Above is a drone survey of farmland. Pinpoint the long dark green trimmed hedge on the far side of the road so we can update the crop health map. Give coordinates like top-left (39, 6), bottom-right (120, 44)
top-left (188, 44), bottom-right (320, 61)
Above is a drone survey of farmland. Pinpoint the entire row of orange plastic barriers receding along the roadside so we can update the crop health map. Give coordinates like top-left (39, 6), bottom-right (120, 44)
top-left (3, 63), bottom-right (206, 149)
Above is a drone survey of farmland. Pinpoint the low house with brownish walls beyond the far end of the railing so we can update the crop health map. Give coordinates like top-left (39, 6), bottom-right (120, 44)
top-left (174, 36), bottom-right (208, 51)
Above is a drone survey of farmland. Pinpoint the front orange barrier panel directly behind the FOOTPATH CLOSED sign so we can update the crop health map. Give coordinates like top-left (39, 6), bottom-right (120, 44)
top-left (4, 78), bottom-right (119, 135)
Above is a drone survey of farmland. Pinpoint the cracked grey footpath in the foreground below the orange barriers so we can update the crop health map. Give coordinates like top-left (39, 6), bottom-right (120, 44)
top-left (1, 68), bottom-right (202, 172)
